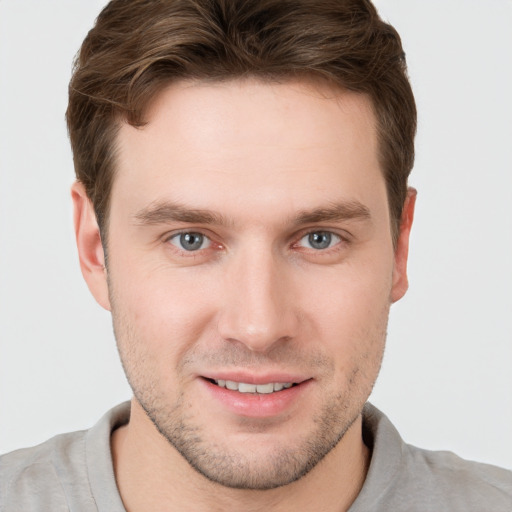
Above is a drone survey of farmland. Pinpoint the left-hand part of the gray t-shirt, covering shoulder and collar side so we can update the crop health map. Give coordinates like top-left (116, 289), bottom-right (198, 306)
top-left (0, 402), bottom-right (130, 512)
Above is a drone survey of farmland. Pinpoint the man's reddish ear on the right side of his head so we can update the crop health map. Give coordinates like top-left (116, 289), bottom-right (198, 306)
top-left (391, 187), bottom-right (417, 302)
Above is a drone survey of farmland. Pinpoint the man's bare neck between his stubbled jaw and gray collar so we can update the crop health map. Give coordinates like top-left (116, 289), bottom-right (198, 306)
top-left (111, 400), bottom-right (370, 512)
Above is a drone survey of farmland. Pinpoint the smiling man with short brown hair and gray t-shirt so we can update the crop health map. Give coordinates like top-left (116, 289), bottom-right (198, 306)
top-left (1, 0), bottom-right (512, 511)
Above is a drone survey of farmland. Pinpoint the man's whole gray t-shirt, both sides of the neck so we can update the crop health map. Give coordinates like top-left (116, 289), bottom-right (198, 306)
top-left (0, 402), bottom-right (512, 512)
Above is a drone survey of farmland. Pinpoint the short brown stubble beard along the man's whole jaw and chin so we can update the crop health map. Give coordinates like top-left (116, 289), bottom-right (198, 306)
top-left (112, 300), bottom-right (385, 490)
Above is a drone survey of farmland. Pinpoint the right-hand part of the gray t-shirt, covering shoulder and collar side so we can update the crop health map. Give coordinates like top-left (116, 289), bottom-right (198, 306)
top-left (351, 404), bottom-right (512, 512)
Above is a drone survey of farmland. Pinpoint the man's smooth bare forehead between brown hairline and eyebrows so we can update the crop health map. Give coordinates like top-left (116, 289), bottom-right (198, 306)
top-left (112, 80), bottom-right (385, 224)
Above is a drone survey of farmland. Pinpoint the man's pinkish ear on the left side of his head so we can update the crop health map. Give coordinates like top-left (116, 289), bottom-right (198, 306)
top-left (71, 181), bottom-right (110, 311)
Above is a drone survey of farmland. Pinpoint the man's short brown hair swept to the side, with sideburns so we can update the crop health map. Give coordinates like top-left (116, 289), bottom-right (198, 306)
top-left (66, 0), bottom-right (416, 241)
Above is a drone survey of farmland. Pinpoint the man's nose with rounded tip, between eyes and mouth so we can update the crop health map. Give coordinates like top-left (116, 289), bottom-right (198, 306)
top-left (218, 250), bottom-right (299, 353)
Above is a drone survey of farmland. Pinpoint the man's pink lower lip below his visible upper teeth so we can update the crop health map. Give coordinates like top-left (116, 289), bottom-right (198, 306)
top-left (201, 379), bottom-right (311, 418)
